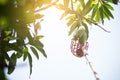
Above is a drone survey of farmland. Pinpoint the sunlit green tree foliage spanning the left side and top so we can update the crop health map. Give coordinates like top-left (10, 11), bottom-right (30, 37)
top-left (0, 0), bottom-right (119, 78)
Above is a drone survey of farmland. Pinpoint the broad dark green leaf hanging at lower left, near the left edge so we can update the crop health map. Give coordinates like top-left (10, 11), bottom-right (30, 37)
top-left (8, 53), bottom-right (17, 74)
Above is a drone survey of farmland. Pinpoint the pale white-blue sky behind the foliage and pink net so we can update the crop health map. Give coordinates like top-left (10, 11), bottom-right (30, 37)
top-left (8, 2), bottom-right (120, 80)
